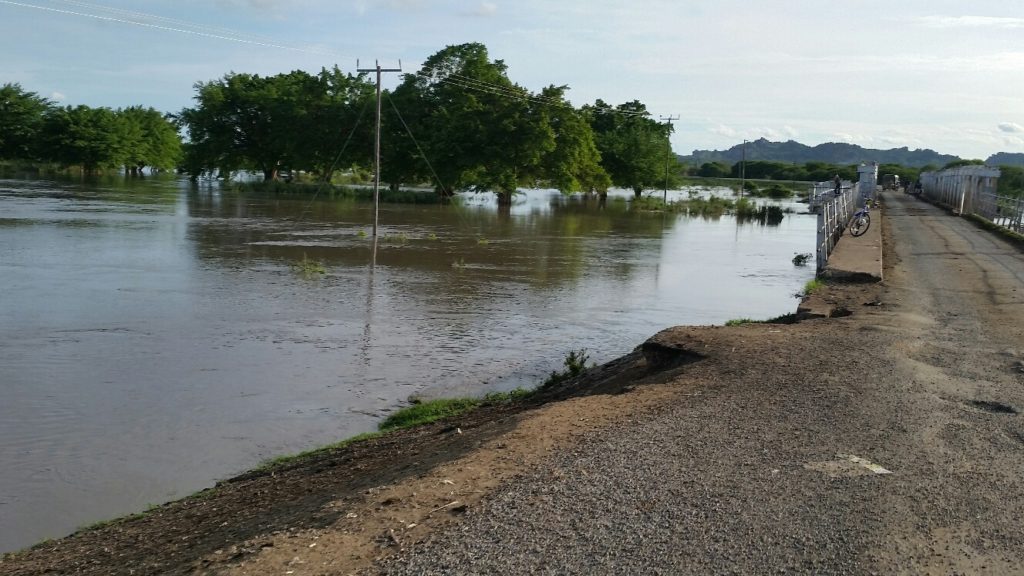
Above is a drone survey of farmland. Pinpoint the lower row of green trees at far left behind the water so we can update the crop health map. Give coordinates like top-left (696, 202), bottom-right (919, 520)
top-left (0, 84), bottom-right (181, 173)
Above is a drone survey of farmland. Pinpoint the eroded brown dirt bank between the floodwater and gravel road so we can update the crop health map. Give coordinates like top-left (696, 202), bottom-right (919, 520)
top-left (0, 218), bottom-right (882, 575)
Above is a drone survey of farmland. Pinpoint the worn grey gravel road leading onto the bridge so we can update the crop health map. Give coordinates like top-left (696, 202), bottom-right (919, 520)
top-left (377, 195), bottom-right (1024, 574)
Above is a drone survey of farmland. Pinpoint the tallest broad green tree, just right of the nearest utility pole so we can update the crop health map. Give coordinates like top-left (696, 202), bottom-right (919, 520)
top-left (383, 43), bottom-right (556, 205)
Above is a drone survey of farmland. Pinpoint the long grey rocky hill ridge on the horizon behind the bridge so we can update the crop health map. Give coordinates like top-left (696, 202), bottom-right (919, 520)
top-left (679, 138), bottom-right (958, 167)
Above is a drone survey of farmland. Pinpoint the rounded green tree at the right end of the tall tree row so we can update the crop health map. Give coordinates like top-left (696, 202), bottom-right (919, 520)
top-left (584, 99), bottom-right (672, 198)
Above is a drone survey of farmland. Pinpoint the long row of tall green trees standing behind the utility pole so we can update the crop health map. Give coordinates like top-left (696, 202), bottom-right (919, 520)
top-left (176, 43), bottom-right (678, 204)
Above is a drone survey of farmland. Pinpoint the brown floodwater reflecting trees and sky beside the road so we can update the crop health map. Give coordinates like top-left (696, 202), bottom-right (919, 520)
top-left (0, 177), bottom-right (815, 551)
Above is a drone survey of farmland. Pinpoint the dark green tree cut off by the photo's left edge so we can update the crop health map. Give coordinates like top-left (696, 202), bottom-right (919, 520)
top-left (0, 84), bottom-right (52, 160)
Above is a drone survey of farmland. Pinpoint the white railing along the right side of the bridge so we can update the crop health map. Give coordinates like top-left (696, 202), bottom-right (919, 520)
top-left (921, 166), bottom-right (1024, 233)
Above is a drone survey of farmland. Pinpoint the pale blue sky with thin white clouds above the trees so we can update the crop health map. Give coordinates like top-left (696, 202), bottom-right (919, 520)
top-left (0, 0), bottom-right (1024, 159)
